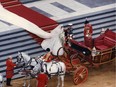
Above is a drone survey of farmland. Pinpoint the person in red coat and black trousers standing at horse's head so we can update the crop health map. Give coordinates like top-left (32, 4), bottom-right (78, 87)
top-left (6, 57), bottom-right (16, 86)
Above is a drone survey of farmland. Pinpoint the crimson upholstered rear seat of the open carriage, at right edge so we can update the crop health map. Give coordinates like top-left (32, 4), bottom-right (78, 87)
top-left (94, 29), bottom-right (116, 50)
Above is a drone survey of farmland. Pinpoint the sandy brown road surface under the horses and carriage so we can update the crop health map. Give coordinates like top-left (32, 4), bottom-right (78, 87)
top-left (5, 61), bottom-right (116, 87)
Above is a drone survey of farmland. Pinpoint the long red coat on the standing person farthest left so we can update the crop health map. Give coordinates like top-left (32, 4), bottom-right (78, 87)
top-left (6, 59), bottom-right (16, 78)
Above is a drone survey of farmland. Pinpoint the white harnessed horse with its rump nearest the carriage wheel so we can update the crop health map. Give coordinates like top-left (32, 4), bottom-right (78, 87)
top-left (32, 58), bottom-right (66, 87)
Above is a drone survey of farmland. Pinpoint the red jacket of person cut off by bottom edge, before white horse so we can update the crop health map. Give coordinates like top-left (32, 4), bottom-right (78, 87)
top-left (37, 74), bottom-right (48, 87)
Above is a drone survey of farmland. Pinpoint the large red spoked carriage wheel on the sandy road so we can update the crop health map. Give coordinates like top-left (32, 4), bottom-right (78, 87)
top-left (73, 66), bottom-right (88, 85)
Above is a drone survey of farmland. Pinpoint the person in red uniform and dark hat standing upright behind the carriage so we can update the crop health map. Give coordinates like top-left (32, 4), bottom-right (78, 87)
top-left (84, 19), bottom-right (93, 48)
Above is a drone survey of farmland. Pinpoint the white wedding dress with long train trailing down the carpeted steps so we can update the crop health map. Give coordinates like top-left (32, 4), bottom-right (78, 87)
top-left (0, 3), bottom-right (63, 55)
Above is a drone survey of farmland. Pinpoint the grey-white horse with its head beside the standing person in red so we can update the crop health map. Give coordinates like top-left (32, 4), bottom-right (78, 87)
top-left (16, 52), bottom-right (37, 87)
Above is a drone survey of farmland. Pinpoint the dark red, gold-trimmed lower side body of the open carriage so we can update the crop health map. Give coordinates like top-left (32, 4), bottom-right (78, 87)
top-left (65, 39), bottom-right (116, 67)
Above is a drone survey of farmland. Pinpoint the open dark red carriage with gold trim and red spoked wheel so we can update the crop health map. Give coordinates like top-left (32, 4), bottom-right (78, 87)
top-left (58, 30), bottom-right (116, 85)
